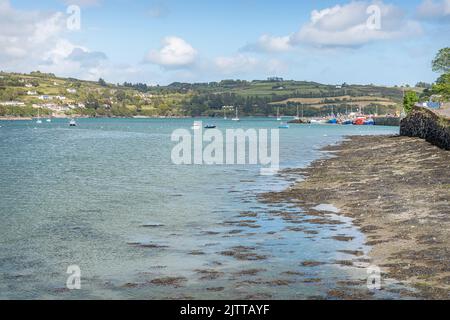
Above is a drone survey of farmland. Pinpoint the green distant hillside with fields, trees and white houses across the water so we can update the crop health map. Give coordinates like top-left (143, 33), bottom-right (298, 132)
top-left (0, 72), bottom-right (410, 117)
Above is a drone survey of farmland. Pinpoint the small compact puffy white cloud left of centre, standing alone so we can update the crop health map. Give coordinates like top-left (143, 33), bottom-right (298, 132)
top-left (145, 36), bottom-right (197, 68)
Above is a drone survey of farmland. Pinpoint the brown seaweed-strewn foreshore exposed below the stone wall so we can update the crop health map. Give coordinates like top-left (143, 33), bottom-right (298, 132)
top-left (263, 136), bottom-right (450, 299)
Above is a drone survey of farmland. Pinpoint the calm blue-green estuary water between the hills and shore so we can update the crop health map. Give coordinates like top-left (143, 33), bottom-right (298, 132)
top-left (0, 119), bottom-right (398, 299)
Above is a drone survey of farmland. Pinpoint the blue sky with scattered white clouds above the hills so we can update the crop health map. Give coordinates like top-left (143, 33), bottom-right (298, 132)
top-left (0, 0), bottom-right (450, 85)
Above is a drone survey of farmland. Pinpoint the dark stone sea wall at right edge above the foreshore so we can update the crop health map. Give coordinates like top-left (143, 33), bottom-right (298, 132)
top-left (400, 107), bottom-right (450, 150)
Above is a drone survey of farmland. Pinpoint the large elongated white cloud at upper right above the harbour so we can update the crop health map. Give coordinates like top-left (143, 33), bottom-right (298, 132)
top-left (291, 1), bottom-right (422, 47)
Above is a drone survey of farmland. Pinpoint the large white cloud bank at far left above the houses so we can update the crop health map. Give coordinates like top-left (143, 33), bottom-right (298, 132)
top-left (0, 0), bottom-right (106, 79)
